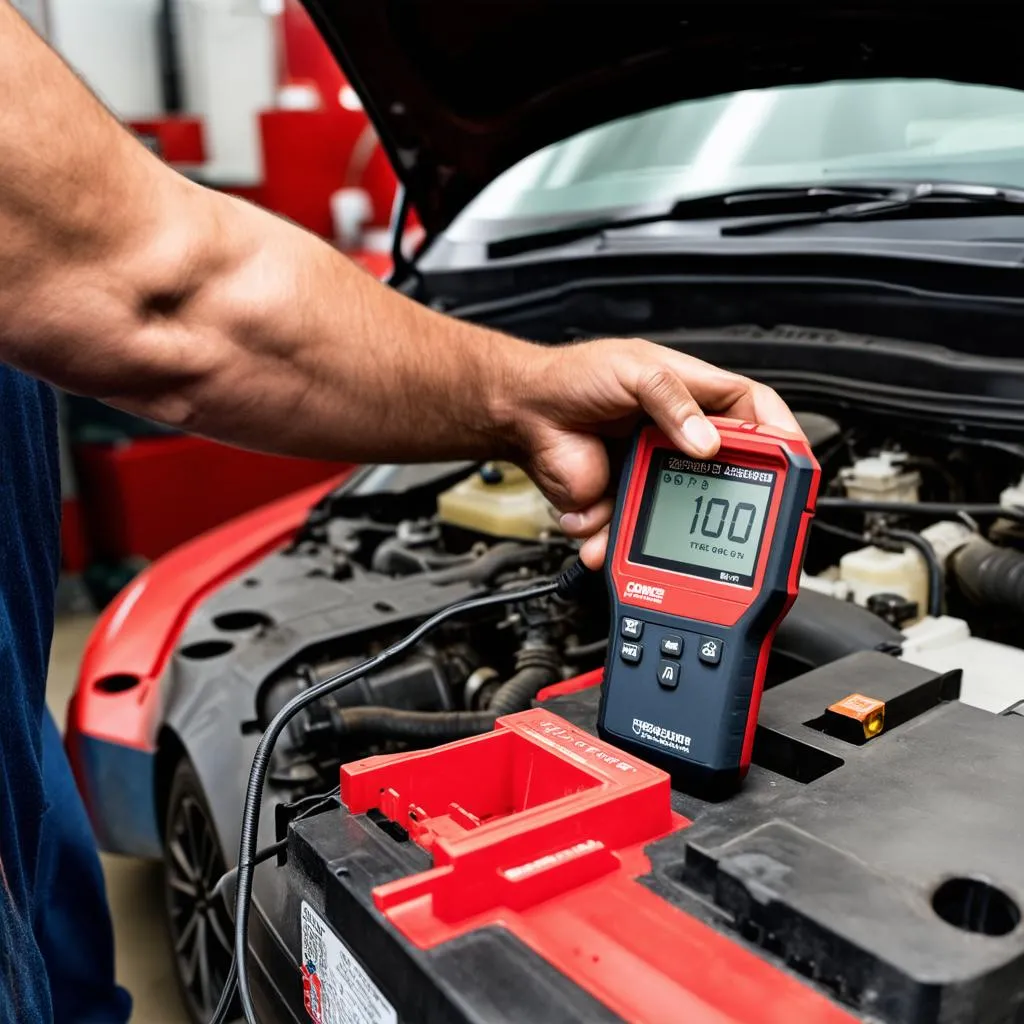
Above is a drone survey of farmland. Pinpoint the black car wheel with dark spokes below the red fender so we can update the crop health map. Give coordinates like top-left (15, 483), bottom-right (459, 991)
top-left (164, 758), bottom-right (241, 1024)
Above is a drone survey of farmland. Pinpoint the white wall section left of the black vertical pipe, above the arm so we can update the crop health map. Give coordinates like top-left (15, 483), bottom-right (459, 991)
top-left (48, 0), bottom-right (163, 120)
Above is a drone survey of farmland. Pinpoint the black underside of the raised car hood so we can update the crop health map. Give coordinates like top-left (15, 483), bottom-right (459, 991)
top-left (302, 0), bottom-right (1024, 233)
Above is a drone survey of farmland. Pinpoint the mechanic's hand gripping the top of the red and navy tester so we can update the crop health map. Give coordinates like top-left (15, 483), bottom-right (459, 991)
top-left (516, 339), bottom-right (801, 568)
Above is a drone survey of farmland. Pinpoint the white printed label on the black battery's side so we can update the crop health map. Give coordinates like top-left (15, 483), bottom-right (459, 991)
top-left (302, 901), bottom-right (398, 1024)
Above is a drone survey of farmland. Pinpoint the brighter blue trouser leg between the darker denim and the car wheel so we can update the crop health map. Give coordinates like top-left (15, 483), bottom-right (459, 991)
top-left (33, 711), bottom-right (131, 1024)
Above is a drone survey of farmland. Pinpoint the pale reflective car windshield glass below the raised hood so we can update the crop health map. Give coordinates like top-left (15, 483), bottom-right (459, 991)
top-left (449, 79), bottom-right (1024, 237)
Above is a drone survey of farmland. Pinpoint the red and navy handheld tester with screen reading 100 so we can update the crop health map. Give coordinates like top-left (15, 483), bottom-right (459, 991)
top-left (598, 418), bottom-right (820, 791)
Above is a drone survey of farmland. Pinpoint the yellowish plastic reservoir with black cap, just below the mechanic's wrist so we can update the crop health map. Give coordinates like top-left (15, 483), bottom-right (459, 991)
top-left (437, 462), bottom-right (558, 541)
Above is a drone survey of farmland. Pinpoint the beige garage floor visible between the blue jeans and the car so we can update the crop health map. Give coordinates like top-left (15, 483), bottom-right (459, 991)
top-left (46, 615), bottom-right (187, 1024)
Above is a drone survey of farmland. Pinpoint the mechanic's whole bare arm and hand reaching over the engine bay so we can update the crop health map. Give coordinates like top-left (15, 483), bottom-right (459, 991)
top-left (0, 0), bottom-right (796, 561)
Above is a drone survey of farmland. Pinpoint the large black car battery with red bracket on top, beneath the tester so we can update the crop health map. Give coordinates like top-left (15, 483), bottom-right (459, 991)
top-left (258, 652), bottom-right (1024, 1024)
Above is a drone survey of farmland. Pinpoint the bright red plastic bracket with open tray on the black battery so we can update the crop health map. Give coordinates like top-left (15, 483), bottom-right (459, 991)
top-left (341, 708), bottom-right (851, 1024)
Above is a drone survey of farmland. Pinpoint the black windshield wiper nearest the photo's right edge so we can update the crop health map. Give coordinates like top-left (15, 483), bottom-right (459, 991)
top-left (721, 182), bottom-right (1024, 237)
